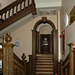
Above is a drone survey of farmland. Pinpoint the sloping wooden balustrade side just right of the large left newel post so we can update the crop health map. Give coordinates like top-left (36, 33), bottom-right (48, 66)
top-left (13, 53), bottom-right (26, 75)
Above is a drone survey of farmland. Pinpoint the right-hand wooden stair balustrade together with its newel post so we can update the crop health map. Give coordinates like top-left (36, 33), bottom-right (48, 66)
top-left (61, 43), bottom-right (75, 75)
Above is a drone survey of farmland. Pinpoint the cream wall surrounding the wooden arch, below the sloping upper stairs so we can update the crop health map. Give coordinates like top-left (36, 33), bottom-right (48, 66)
top-left (11, 15), bottom-right (57, 60)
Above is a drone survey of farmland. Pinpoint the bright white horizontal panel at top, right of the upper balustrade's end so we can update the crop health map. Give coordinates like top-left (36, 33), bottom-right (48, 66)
top-left (35, 0), bottom-right (62, 8)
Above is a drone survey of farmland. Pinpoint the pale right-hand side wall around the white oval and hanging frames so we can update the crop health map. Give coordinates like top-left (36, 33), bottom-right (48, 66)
top-left (61, 0), bottom-right (75, 59)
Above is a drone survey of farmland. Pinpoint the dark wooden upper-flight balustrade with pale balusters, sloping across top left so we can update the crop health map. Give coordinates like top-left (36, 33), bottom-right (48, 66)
top-left (0, 0), bottom-right (36, 30)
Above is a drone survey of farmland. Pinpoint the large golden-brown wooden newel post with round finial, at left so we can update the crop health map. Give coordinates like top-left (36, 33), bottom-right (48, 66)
top-left (2, 33), bottom-right (14, 75)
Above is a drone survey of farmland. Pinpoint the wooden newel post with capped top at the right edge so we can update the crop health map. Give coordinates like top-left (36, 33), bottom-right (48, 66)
top-left (68, 43), bottom-right (75, 75)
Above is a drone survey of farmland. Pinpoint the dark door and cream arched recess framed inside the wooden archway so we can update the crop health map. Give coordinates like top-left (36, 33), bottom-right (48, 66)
top-left (36, 23), bottom-right (52, 54)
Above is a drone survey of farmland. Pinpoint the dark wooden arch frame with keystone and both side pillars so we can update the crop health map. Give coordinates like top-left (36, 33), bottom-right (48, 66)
top-left (32, 17), bottom-right (58, 74)
